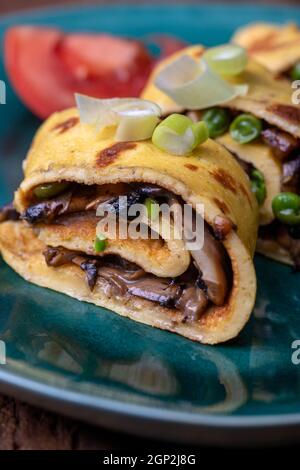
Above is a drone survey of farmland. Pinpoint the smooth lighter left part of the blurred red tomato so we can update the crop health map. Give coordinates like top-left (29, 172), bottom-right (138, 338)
top-left (4, 26), bottom-right (73, 118)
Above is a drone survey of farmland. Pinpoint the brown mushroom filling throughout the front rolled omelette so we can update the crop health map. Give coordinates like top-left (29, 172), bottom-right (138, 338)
top-left (2, 183), bottom-right (232, 322)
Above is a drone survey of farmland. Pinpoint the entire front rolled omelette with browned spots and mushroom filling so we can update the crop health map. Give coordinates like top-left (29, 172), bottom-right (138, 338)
top-left (0, 109), bottom-right (258, 344)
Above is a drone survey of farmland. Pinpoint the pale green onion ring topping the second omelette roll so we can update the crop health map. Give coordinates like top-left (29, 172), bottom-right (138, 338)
top-left (203, 44), bottom-right (248, 76)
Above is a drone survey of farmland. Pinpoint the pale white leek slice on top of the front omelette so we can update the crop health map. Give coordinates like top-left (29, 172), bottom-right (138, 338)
top-left (75, 94), bottom-right (161, 142)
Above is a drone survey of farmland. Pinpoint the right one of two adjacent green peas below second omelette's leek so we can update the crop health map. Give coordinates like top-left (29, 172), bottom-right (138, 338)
top-left (230, 114), bottom-right (262, 144)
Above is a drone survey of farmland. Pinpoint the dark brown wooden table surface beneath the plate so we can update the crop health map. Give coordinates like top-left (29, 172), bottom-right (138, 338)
top-left (0, 0), bottom-right (299, 450)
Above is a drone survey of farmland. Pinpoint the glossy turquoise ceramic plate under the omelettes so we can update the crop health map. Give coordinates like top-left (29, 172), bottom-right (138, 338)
top-left (0, 5), bottom-right (300, 444)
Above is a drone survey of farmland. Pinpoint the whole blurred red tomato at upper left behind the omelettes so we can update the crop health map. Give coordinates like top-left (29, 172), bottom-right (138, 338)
top-left (4, 26), bottom-right (154, 118)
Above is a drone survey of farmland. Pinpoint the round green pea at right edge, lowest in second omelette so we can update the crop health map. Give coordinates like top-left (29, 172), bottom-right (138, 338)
top-left (272, 192), bottom-right (300, 225)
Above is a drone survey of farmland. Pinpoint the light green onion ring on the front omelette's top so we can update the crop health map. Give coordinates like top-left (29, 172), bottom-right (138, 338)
top-left (152, 114), bottom-right (208, 155)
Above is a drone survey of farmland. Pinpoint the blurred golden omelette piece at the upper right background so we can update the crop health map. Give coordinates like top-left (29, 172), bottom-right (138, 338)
top-left (232, 23), bottom-right (300, 78)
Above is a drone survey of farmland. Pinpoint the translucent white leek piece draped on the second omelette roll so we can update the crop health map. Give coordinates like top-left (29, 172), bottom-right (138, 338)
top-left (155, 55), bottom-right (246, 110)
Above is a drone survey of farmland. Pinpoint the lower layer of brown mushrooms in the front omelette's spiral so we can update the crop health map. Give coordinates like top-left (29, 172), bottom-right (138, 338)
top-left (44, 247), bottom-right (210, 322)
